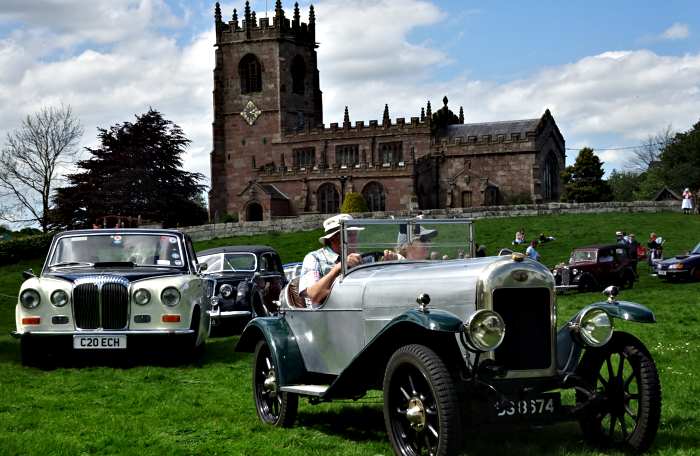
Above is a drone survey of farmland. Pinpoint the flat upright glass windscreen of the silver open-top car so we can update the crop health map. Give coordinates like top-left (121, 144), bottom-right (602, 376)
top-left (345, 220), bottom-right (470, 260)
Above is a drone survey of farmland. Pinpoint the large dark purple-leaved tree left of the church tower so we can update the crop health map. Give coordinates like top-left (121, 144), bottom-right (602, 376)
top-left (53, 109), bottom-right (206, 228)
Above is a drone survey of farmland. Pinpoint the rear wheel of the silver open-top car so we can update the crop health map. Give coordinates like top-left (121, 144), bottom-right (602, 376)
top-left (253, 339), bottom-right (299, 428)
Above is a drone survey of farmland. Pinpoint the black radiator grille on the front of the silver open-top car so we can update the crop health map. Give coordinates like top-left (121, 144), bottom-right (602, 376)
top-left (493, 288), bottom-right (552, 370)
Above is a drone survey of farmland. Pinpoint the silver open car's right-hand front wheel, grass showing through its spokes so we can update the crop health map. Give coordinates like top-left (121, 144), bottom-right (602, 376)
top-left (577, 333), bottom-right (661, 451)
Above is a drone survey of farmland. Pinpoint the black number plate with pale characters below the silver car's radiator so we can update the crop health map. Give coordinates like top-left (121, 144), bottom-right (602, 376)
top-left (489, 393), bottom-right (562, 421)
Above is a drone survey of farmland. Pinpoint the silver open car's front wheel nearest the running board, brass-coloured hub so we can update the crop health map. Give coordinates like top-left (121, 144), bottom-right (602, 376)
top-left (384, 345), bottom-right (460, 456)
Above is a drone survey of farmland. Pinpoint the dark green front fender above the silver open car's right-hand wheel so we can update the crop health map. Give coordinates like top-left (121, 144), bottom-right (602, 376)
top-left (557, 301), bottom-right (657, 374)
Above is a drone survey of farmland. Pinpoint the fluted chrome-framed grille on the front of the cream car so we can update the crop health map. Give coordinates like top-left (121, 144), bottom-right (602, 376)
top-left (73, 276), bottom-right (129, 330)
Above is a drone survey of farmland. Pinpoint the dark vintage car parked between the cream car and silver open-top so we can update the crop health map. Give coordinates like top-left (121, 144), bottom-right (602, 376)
top-left (197, 245), bottom-right (287, 325)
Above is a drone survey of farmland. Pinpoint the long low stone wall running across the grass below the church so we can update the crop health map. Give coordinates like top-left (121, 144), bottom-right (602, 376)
top-left (180, 201), bottom-right (681, 242)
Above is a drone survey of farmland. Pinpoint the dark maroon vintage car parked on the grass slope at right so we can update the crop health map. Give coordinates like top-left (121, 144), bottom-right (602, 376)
top-left (553, 244), bottom-right (636, 292)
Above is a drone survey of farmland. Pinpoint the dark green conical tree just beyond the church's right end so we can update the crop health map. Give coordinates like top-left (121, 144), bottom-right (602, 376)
top-left (560, 147), bottom-right (613, 203)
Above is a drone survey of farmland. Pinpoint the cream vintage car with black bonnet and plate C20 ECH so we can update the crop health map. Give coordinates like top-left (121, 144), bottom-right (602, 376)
top-left (12, 229), bottom-right (212, 365)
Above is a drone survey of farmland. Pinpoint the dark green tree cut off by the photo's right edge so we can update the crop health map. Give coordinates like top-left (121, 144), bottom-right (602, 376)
top-left (661, 122), bottom-right (700, 191)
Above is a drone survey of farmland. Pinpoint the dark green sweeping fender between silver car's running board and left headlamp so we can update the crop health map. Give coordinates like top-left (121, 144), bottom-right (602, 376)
top-left (321, 309), bottom-right (464, 399)
